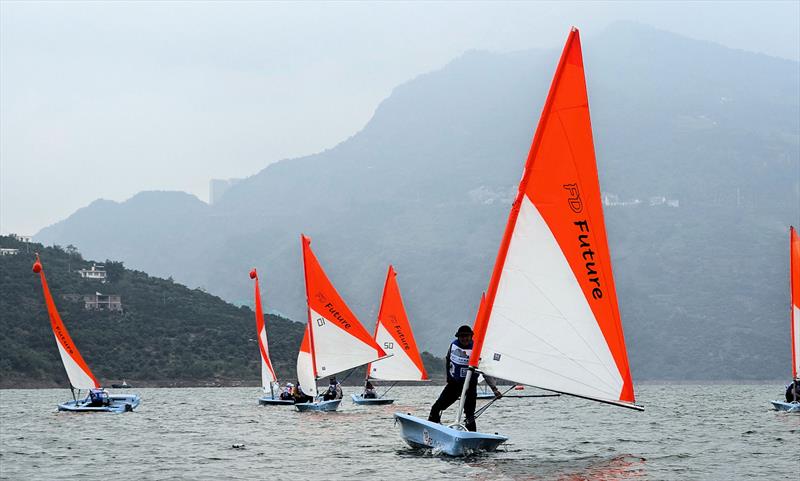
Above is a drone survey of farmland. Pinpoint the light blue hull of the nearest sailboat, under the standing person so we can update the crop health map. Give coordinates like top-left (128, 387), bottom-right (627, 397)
top-left (394, 413), bottom-right (508, 456)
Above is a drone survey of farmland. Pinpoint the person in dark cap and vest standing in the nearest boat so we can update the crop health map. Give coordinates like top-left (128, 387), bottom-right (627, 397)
top-left (428, 326), bottom-right (503, 431)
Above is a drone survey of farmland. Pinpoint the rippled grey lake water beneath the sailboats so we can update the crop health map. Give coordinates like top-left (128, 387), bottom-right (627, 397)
top-left (0, 383), bottom-right (800, 480)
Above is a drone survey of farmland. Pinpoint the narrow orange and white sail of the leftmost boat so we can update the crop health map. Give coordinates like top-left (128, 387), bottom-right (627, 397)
top-left (33, 255), bottom-right (100, 389)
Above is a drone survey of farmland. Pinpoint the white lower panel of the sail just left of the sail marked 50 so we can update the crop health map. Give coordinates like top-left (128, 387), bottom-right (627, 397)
top-left (309, 308), bottom-right (378, 378)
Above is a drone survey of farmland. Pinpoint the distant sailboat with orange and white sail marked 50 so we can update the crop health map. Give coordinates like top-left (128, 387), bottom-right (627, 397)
top-left (351, 266), bottom-right (428, 405)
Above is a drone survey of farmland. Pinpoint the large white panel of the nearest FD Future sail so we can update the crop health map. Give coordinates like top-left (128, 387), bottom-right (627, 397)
top-left (479, 195), bottom-right (623, 403)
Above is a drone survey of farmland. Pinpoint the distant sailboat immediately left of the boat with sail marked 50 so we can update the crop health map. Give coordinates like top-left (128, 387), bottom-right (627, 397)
top-left (295, 235), bottom-right (386, 411)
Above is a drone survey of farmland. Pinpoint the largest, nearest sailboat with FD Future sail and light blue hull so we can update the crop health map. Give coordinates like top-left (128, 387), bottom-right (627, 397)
top-left (395, 28), bottom-right (643, 456)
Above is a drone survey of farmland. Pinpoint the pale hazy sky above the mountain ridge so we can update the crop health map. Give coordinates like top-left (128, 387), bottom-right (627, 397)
top-left (0, 0), bottom-right (800, 234)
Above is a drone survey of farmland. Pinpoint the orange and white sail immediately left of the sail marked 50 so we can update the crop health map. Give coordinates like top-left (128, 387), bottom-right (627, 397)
top-left (301, 236), bottom-right (386, 382)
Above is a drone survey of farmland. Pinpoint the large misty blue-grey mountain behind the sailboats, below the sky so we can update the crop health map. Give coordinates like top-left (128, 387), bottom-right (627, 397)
top-left (36, 23), bottom-right (800, 379)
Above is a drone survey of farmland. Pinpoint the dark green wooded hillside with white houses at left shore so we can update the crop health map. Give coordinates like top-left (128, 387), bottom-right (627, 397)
top-left (0, 236), bottom-right (442, 387)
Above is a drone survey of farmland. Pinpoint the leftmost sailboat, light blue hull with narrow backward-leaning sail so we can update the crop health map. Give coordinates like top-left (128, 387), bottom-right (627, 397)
top-left (33, 254), bottom-right (141, 413)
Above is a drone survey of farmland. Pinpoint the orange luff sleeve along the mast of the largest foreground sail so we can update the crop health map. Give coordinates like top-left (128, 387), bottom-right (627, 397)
top-left (470, 27), bottom-right (578, 367)
